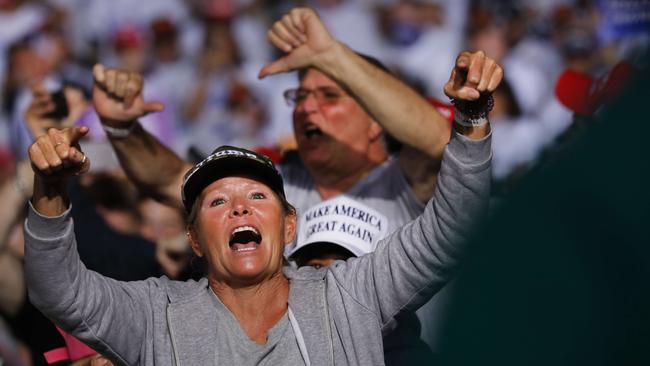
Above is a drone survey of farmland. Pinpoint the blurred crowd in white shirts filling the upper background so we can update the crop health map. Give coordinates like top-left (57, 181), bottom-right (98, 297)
top-left (0, 0), bottom-right (648, 179)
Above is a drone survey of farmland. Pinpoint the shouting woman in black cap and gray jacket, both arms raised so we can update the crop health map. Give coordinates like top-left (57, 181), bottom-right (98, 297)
top-left (25, 35), bottom-right (500, 365)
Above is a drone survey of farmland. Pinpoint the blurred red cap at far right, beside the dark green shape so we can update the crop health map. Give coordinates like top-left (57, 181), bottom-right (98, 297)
top-left (555, 62), bottom-right (634, 116)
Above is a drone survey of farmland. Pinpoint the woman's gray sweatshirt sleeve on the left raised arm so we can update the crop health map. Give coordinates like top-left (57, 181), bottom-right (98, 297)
top-left (25, 206), bottom-right (157, 365)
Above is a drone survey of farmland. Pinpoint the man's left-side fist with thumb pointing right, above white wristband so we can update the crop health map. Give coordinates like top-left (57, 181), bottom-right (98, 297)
top-left (93, 64), bottom-right (165, 127)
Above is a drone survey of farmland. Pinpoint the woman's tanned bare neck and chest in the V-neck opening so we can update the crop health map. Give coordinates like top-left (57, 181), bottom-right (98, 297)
top-left (210, 273), bottom-right (289, 344)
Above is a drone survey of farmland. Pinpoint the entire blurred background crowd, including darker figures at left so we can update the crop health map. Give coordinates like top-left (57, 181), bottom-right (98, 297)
top-left (0, 0), bottom-right (650, 364)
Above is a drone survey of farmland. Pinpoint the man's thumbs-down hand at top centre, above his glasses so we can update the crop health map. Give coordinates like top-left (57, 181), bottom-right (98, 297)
top-left (259, 8), bottom-right (337, 78)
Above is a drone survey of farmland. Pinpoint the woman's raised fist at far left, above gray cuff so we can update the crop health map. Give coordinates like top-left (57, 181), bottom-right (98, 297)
top-left (28, 127), bottom-right (90, 182)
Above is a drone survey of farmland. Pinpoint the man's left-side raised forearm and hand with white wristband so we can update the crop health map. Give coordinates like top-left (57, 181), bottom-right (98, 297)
top-left (93, 65), bottom-right (191, 207)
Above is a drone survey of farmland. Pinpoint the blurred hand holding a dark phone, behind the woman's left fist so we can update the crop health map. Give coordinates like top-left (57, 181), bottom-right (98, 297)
top-left (25, 83), bottom-right (88, 138)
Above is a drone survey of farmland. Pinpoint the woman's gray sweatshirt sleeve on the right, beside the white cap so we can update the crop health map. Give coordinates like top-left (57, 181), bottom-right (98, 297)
top-left (331, 132), bottom-right (491, 325)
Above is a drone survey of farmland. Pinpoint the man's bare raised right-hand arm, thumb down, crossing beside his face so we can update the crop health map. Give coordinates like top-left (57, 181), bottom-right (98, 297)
top-left (260, 8), bottom-right (450, 202)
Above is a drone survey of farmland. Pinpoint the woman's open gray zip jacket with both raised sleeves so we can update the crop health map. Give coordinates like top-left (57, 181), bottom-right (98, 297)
top-left (25, 132), bottom-right (491, 365)
